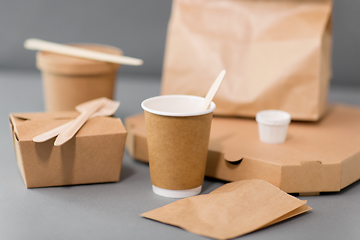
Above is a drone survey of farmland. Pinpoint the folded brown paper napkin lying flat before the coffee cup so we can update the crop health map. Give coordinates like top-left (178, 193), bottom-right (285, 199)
top-left (141, 179), bottom-right (311, 239)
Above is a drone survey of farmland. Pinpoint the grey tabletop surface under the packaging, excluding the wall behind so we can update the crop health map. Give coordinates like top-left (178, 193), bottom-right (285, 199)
top-left (0, 71), bottom-right (360, 240)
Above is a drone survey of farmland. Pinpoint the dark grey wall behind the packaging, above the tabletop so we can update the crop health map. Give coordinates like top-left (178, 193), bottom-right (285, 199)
top-left (0, 0), bottom-right (360, 85)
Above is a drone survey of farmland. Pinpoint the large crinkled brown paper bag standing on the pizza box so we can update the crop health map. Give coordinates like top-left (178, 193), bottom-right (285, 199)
top-left (162, 0), bottom-right (332, 121)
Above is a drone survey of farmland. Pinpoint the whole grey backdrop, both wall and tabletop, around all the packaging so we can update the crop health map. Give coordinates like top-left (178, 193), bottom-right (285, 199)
top-left (0, 0), bottom-right (360, 240)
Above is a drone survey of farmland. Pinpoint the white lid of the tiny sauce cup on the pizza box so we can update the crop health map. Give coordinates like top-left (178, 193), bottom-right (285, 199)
top-left (256, 110), bottom-right (291, 126)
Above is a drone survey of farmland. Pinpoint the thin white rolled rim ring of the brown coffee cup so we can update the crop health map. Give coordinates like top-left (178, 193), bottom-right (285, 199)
top-left (141, 95), bottom-right (216, 117)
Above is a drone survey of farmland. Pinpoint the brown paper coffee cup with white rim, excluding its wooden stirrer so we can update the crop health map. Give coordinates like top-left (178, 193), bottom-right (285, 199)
top-left (141, 95), bottom-right (216, 198)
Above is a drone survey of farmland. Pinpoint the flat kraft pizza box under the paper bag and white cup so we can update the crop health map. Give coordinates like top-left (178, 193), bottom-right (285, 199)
top-left (125, 104), bottom-right (360, 195)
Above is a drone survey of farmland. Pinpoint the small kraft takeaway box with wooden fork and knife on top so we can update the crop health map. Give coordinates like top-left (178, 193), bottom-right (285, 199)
top-left (10, 111), bottom-right (127, 188)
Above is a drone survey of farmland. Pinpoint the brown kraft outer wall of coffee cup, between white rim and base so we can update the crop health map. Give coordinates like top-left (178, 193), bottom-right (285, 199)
top-left (144, 111), bottom-right (212, 190)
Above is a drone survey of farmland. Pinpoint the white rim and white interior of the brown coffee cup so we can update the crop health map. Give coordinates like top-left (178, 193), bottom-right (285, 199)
top-left (141, 95), bottom-right (216, 117)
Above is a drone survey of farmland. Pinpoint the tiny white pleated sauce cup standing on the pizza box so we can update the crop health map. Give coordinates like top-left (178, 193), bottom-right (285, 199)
top-left (256, 110), bottom-right (291, 144)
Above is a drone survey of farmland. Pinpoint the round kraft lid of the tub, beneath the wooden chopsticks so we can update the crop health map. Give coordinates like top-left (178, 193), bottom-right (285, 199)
top-left (36, 43), bottom-right (123, 75)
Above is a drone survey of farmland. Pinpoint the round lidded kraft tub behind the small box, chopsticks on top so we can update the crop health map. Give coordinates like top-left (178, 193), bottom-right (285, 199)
top-left (37, 44), bottom-right (122, 111)
